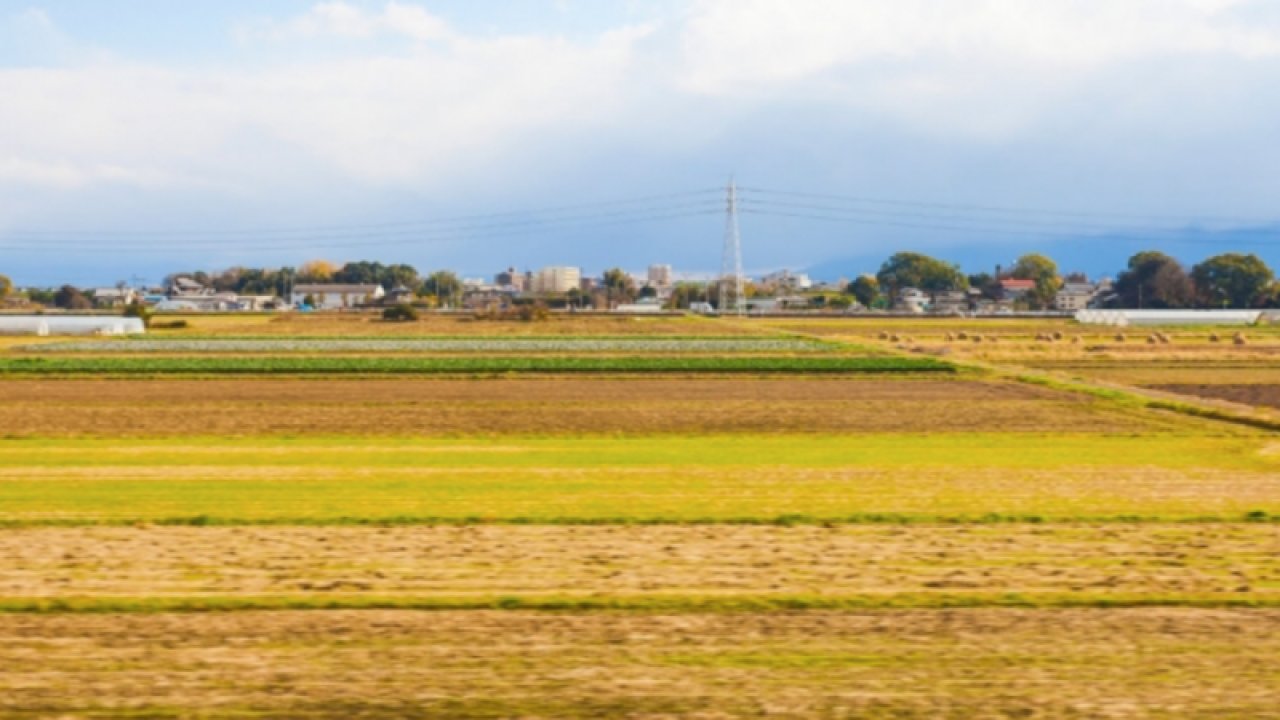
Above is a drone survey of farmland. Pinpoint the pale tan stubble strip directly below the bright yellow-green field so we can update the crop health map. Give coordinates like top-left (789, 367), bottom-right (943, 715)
top-left (0, 524), bottom-right (1280, 600)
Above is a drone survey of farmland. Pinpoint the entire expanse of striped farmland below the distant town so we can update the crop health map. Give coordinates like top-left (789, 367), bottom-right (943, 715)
top-left (0, 315), bottom-right (1280, 719)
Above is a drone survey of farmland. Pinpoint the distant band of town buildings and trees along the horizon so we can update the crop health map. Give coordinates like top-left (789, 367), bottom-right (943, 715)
top-left (0, 245), bottom-right (1280, 315)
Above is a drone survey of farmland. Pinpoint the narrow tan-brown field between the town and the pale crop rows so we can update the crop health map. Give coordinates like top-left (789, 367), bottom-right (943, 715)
top-left (152, 313), bottom-right (771, 337)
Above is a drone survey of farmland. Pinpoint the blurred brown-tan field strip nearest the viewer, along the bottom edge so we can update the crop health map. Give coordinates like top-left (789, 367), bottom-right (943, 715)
top-left (0, 609), bottom-right (1280, 720)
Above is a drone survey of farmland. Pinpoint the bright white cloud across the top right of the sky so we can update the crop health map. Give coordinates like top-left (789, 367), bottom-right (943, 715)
top-left (684, 0), bottom-right (1280, 94)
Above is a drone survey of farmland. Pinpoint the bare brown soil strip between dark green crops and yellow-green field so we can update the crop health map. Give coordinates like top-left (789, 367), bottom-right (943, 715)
top-left (0, 378), bottom-right (1172, 437)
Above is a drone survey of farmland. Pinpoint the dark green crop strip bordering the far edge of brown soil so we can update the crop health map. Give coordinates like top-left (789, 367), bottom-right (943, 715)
top-left (0, 356), bottom-right (955, 375)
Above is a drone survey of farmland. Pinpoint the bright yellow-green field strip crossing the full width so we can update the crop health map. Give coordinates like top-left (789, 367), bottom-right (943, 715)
top-left (0, 433), bottom-right (1280, 524)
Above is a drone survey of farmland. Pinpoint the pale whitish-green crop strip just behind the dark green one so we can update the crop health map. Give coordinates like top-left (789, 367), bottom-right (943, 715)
top-left (24, 338), bottom-right (833, 354)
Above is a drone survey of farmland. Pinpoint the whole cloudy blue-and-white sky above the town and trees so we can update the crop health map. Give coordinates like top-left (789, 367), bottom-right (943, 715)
top-left (0, 0), bottom-right (1280, 283)
